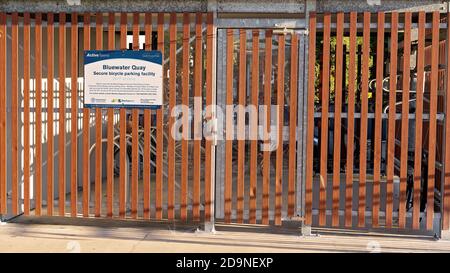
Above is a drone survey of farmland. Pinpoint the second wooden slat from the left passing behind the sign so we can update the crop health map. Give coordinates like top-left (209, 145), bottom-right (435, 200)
top-left (95, 13), bottom-right (103, 217)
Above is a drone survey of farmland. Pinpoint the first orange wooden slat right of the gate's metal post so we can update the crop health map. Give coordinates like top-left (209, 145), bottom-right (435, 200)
top-left (319, 13), bottom-right (331, 226)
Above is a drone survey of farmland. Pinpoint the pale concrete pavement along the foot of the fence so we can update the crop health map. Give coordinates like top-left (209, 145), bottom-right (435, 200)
top-left (0, 216), bottom-right (450, 253)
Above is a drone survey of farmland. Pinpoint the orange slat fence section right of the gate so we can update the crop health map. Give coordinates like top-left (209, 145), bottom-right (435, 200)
top-left (305, 11), bottom-right (448, 233)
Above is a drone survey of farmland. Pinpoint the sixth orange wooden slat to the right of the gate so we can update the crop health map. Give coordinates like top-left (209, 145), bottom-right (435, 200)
top-left (386, 12), bottom-right (398, 228)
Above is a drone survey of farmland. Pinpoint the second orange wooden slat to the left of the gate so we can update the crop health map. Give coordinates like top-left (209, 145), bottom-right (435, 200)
top-left (192, 13), bottom-right (202, 221)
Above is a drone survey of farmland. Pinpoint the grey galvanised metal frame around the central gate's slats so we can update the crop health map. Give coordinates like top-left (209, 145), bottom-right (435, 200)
top-left (215, 17), bottom-right (309, 223)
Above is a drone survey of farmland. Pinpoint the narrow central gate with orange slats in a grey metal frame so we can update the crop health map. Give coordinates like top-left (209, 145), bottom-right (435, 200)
top-left (215, 15), bottom-right (305, 225)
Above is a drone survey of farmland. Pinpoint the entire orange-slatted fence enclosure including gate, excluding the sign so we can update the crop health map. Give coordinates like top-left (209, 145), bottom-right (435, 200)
top-left (0, 0), bottom-right (450, 237)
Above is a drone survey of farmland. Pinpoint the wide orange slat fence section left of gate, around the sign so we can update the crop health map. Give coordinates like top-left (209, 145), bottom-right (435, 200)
top-left (0, 13), bottom-right (215, 221)
